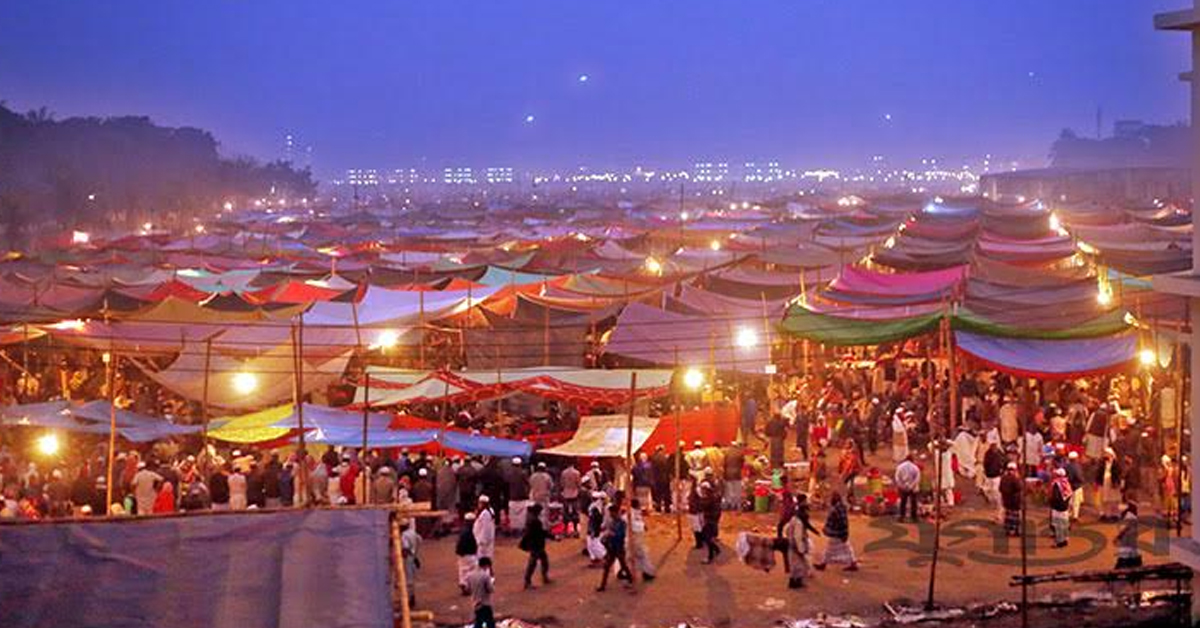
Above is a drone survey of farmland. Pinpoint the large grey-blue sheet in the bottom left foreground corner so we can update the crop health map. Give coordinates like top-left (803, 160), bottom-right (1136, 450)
top-left (0, 509), bottom-right (392, 628)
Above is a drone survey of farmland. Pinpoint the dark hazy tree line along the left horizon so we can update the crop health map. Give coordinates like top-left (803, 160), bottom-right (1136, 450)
top-left (0, 103), bottom-right (317, 246)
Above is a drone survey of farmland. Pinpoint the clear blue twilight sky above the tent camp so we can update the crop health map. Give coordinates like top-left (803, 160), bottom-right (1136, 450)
top-left (0, 0), bottom-right (1189, 177)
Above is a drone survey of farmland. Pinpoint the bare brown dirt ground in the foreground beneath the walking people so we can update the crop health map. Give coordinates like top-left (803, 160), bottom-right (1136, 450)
top-left (416, 449), bottom-right (1188, 628)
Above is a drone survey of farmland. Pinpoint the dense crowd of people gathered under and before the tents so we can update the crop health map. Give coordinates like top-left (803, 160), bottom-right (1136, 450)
top-left (0, 359), bottom-right (1190, 626)
